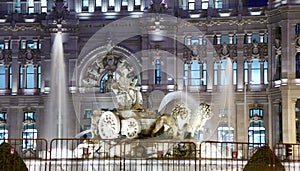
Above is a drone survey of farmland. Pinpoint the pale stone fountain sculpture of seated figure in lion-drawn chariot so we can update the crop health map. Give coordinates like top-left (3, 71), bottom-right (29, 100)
top-left (76, 61), bottom-right (213, 157)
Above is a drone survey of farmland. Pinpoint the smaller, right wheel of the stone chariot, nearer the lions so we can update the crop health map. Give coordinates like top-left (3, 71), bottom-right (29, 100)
top-left (124, 118), bottom-right (141, 139)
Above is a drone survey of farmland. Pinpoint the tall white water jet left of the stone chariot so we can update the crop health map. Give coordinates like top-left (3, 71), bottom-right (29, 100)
top-left (45, 32), bottom-right (72, 140)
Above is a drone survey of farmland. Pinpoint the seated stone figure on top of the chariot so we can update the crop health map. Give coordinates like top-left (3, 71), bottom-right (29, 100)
top-left (111, 62), bottom-right (143, 110)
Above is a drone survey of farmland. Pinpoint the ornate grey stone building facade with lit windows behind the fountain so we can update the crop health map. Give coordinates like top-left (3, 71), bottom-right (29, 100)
top-left (0, 0), bottom-right (300, 148)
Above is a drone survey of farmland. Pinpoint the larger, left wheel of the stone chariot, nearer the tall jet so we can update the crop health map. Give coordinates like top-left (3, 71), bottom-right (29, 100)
top-left (98, 111), bottom-right (121, 139)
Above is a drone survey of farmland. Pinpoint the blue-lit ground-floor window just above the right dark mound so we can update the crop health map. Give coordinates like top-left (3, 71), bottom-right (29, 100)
top-left (248, 119), bottom-right (266, 148)
